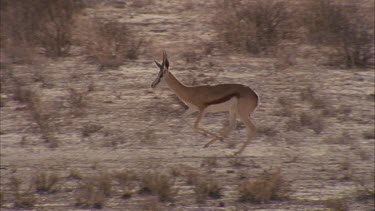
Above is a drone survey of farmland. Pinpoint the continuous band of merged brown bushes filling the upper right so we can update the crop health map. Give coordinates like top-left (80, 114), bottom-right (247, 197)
top-left (214, 0), bottom-right (374, 68)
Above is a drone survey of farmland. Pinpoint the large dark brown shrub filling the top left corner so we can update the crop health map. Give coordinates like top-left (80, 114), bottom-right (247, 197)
top-left (0, 0), bottom-right (82, 61)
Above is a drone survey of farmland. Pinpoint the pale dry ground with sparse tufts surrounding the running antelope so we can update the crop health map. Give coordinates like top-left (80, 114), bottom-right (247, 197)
top-left (0, 0), bottom-right (375, 211)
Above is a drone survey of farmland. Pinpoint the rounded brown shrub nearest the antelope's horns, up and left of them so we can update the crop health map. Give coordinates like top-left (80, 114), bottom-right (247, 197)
top-left (77, 18), bottom-right (144, 69)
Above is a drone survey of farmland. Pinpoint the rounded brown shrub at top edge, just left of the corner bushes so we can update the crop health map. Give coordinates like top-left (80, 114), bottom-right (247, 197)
top-left (215, 0), bottom-right (290, 54)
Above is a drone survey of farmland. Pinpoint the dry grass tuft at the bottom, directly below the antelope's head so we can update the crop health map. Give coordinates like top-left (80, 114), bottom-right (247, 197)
top-left (139, 172), bottom-right (176, 202)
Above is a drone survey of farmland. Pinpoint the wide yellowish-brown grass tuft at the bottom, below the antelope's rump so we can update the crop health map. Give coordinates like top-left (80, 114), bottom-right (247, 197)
top-left (238, 170), bottom-right (289, 203)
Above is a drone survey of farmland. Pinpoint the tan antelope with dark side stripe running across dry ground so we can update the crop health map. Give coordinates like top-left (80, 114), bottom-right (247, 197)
top-left (151, 51), bottom-right (259, 155)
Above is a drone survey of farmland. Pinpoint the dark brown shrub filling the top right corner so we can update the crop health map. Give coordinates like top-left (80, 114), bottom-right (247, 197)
top-left (303, 0), bottom-right (374, 68)
